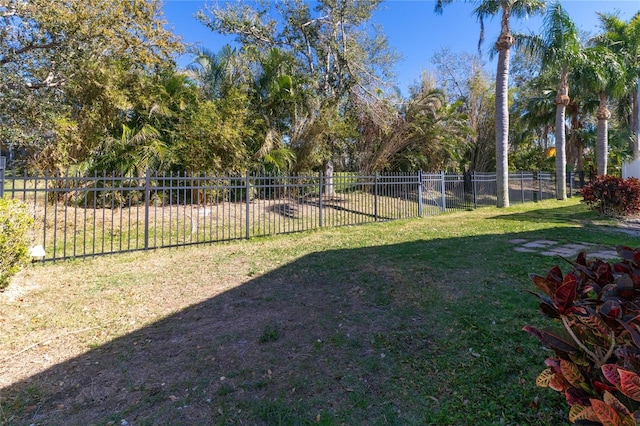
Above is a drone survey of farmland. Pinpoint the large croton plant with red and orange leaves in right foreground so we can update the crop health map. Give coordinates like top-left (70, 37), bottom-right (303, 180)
top-left (524, 246), bottom-right (640, 426)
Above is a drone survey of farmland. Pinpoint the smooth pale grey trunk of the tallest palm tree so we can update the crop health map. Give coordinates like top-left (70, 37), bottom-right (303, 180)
top-left (496, 42), bottom-right (511, 207)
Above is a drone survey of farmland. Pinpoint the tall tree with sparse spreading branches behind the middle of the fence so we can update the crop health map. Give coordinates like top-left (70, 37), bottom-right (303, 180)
top-left (198, 0), bottom-right (394, 188)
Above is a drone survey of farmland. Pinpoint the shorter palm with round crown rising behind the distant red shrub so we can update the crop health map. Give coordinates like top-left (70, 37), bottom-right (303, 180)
top-left (574, 46), bottom-right (625, 176)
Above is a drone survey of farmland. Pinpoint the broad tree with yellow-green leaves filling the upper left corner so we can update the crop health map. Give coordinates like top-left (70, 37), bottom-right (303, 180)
top-left (0, 0), bottom-right (182, 170)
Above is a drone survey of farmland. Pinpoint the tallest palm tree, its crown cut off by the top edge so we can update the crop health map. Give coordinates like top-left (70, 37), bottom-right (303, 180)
top-left (436, 0), bottom-right (546, 207)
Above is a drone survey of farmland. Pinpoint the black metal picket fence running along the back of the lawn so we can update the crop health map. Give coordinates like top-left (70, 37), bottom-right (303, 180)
top-left (0, 161), bottom-right (574, 261)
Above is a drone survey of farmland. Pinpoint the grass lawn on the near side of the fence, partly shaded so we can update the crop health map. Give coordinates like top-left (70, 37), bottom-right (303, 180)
top-left (0, 198), bottom-right (638, 425)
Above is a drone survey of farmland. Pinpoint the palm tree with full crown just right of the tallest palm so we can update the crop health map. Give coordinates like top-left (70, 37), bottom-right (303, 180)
top-left (523, 2), bottom-right (581, 200)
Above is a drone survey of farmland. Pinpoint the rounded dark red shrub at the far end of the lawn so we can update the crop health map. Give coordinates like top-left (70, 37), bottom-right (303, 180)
top-left (582, 176), bottom-right (640, 217)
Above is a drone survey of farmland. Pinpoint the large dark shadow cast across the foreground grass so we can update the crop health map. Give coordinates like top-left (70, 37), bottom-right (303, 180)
top-left (0, 230), bottom-right (604, 425)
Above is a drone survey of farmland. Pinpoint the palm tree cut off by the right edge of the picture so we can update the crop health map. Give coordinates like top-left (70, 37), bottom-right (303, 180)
top-left (597, 12), bottom-right (640, 160)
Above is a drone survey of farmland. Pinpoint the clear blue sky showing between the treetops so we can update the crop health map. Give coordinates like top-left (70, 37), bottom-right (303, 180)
top-left (164, 0), bottom-right (640, 93)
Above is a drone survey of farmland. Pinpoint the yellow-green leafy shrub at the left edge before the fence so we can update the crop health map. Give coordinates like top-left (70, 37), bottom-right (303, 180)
top-left (0, 198), bottom-right (33, 290)
